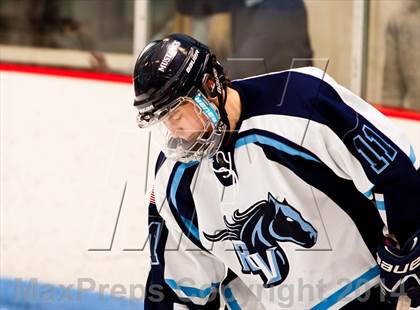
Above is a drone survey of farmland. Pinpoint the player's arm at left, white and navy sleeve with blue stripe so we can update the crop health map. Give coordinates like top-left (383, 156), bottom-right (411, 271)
top-left (144, 197), bottom-right (224, 310)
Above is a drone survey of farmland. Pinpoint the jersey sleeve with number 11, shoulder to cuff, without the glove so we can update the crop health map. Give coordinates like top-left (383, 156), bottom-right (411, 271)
top-left (302, 68), bottom-right (420, 243)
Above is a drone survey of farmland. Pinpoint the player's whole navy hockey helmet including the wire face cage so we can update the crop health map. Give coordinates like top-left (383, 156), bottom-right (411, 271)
top-left (133, 34), bottom-right (228, 162)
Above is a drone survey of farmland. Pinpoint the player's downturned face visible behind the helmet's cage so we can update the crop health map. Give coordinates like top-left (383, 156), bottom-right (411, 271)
top-left (163, 101), bottom-right (208, 142)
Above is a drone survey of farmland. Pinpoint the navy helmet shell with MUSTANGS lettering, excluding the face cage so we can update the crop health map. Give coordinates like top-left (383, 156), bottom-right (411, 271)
top-left (133, 34), bottom-right (225, 127)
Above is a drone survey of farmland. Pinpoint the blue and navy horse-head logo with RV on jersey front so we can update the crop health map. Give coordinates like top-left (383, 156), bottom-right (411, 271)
top-left (204, 193), bottom-right (317, 287)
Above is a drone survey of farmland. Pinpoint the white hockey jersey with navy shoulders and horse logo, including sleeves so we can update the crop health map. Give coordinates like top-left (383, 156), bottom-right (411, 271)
top-left (145, 67), bottom-right (420, 310)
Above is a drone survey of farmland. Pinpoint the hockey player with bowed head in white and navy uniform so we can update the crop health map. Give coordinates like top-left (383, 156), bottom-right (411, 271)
top-left (134, 34), bottom-right (420, 310)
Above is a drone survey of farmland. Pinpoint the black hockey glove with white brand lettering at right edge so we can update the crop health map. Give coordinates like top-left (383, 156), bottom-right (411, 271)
top-left (378, 230), bottom-right (420, 307)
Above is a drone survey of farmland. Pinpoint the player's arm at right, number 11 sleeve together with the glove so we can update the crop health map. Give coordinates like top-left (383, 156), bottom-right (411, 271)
top-left (310, 69), bottom-right (420, 304)
